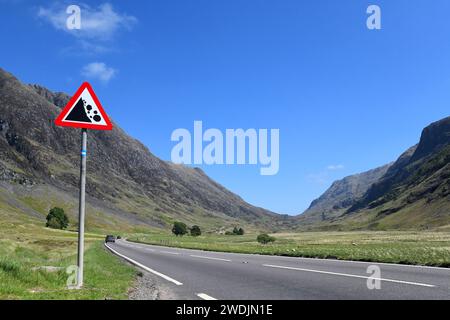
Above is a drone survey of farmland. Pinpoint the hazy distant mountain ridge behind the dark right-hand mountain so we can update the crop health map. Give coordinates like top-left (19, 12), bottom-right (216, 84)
top-left (299, 164), bottom-right (391, 223)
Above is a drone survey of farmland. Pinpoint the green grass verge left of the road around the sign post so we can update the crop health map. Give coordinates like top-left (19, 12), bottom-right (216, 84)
top-left (0, 217), bottom-right (137, 300)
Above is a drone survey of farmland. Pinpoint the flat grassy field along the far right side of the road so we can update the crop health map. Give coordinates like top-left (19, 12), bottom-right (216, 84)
top-left (128, 231), bottom-right (450, 267)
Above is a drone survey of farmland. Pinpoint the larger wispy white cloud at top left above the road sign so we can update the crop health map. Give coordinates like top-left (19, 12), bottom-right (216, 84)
top-left (37, 3), bottom-right (138, 41)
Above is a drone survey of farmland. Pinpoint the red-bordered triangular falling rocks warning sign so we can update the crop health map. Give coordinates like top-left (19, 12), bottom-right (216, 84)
top-left (55, 82), bottom-right (112, 130)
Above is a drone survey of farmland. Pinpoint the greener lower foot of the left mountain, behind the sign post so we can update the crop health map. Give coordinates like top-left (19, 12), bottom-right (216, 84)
top-left (0, 181), bottom-right (243, 233)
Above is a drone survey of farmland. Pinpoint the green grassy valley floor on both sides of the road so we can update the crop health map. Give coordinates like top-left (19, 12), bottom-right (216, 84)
top-left (0, 221), bottom-right (450, 299)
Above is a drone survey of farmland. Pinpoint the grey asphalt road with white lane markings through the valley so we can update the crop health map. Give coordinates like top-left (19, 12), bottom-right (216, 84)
top-left (107, 240), bottom-right (450, 300)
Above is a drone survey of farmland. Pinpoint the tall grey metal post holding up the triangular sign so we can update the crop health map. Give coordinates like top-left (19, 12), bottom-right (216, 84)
top-left (77, 129), bottom-right (87, 288)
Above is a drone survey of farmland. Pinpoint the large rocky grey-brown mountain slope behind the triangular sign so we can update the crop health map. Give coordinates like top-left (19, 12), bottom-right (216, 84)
top-left (0, 69), bottom-right (280, 232)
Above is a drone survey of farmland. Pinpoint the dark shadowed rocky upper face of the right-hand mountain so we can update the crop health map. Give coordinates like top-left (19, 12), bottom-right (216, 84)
top-left (348, 117), bottom-right (450, 219)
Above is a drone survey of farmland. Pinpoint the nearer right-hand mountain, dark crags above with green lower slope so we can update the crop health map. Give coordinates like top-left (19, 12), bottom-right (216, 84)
top-left (299, 117), bottom-right (450, 230)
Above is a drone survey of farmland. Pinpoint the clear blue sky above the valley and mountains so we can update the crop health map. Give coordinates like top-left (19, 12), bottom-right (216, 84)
top-left (0, 0), bottom-right (450, 214)
